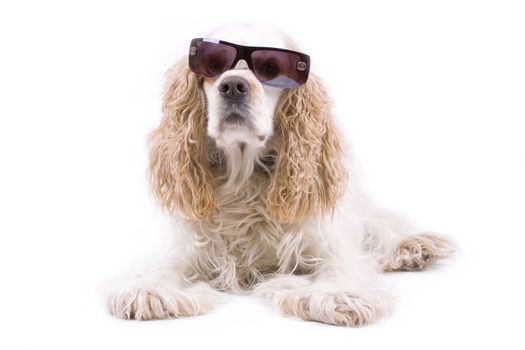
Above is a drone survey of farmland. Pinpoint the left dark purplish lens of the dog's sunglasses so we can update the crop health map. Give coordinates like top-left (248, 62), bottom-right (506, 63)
top-left (189, 40), bottom-right (237, 77)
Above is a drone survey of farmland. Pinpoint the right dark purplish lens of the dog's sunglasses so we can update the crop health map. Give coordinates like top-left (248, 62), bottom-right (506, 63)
top-left (251, 50), bottom-right (308, 88)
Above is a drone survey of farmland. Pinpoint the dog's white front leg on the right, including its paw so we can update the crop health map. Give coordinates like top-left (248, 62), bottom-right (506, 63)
top-left (255, 262), bottom-right (392, 327)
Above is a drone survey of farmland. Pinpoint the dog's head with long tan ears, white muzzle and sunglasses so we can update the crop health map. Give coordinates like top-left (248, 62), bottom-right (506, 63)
top-left (150, 25), bottom-right (346, 223)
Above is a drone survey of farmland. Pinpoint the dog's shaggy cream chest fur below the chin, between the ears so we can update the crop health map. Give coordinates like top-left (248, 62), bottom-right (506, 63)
top-left (189, 178), bottom-right (290, 289)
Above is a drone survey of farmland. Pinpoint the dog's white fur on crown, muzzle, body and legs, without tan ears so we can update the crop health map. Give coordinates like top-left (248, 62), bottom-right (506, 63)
top-left (108, 26), bottom-right (451, 326)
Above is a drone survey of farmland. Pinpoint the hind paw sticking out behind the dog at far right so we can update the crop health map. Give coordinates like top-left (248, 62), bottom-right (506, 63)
top-left (381, 233), bottom-right (455, 272)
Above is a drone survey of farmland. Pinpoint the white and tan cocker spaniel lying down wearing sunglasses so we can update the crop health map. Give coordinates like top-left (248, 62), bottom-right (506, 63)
top-left (108, 25), bottom-right (453, 326)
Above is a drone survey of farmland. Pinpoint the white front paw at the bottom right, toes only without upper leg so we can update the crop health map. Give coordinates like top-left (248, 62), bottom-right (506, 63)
top-left (274, 292), bottom-right (389, 327)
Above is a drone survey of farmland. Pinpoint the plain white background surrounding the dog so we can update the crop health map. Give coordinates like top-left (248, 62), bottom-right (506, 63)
top-left (0, 0), bottom-right (525, 349)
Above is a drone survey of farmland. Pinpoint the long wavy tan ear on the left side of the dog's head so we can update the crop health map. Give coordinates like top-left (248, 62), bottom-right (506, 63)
top-left (149, 58), bottom-right (215, 219)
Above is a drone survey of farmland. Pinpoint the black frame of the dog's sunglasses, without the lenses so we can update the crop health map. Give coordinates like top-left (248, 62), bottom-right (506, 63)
top-left (188, 38), bottom-right (310, 85)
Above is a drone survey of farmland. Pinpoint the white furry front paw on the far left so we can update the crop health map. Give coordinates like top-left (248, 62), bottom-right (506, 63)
top-left (107, 287), bottom-right (204, 320)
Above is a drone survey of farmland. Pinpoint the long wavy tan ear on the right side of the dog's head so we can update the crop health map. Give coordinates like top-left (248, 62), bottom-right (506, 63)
top-left (267, 74), bottom-right (347, 223)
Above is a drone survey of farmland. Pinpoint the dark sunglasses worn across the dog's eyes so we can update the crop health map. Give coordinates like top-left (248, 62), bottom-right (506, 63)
top-left (189, 38), bottom-right (310, 88)
